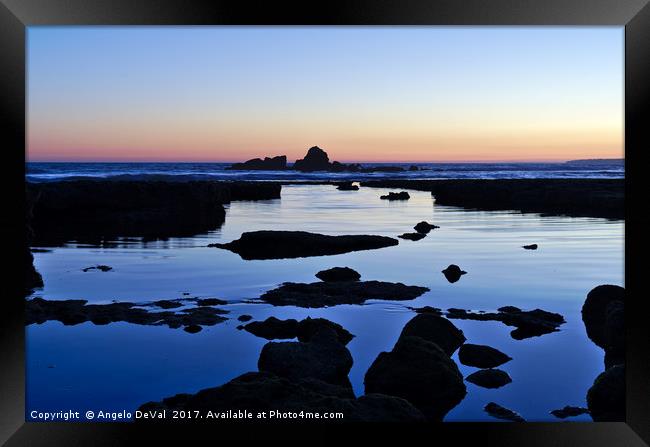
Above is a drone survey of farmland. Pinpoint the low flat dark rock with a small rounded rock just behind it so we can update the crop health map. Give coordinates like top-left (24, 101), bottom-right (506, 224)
top-left (260, 281), bottom-right (429, 307)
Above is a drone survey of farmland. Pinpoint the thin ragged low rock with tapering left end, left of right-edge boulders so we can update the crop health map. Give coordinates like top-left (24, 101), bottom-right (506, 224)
top-left (446, 306), bottom-right (565, 340)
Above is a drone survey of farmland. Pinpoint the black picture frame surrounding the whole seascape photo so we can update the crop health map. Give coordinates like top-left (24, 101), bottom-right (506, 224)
top-left (0, 0), bottom-right (650, 446)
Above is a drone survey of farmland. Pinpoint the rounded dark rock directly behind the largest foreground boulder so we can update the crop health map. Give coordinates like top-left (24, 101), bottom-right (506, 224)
top-left (400, 313), bottom-right (465, 356)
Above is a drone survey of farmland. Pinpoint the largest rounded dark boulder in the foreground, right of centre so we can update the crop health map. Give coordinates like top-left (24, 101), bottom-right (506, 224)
top-left (364, 337), bottom-right (466, 421)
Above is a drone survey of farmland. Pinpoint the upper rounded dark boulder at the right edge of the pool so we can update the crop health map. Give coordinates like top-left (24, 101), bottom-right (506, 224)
top-left (582, 284), bottom-right (625, 349)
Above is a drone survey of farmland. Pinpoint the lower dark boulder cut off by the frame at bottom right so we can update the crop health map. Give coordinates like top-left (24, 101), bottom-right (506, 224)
top-left (587, 365), bottom-right (625, 422)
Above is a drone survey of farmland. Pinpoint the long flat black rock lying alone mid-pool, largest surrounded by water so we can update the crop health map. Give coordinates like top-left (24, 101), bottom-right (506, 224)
top-left (208, 230), bottom-right (399, 260)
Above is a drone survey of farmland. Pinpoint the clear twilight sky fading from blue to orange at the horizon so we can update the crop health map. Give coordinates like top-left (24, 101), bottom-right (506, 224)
top-left (27, 26), bottom-right (624, 162)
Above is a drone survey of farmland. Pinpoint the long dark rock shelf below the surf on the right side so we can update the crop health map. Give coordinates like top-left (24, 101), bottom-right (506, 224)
top-left (361, 179), bottom-right (625, 219)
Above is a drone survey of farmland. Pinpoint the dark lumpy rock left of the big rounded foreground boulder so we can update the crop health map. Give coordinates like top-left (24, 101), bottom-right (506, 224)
top-left (257, 328), bottom-right (352, 385)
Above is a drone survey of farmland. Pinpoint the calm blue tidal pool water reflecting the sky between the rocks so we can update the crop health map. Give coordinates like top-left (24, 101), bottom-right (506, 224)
top-left (27, 186), bottom-right (624, 421)
